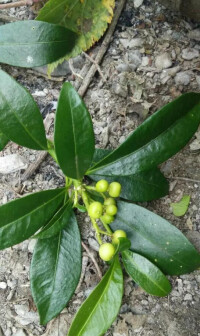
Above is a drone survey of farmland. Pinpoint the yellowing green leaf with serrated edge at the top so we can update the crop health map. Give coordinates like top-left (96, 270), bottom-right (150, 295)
top-left (37, 0), bottom-right (115, 72)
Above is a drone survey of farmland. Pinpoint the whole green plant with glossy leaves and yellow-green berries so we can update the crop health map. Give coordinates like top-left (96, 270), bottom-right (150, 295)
top-left (0, 70), bottom-right (200, 336)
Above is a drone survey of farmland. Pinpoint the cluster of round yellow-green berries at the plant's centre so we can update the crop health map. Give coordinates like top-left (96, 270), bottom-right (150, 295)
top-left (88, 180), bottom-right (126, 261)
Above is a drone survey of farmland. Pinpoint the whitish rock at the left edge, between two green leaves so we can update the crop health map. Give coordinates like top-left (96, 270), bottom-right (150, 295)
top-left (0, 154), bottom-right (27, 174)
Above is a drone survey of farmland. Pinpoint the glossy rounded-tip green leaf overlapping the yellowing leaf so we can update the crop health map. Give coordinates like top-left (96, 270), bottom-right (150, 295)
top-left (0, 20), bottom-right (76, 68)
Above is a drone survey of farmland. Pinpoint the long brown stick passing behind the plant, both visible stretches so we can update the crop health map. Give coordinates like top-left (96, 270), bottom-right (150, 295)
top-left (12, 0), bottom-right (126, 192)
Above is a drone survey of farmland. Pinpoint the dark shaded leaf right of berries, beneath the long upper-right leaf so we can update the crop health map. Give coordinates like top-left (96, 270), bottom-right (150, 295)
top-left (89, 149), bottom-right (169, 202)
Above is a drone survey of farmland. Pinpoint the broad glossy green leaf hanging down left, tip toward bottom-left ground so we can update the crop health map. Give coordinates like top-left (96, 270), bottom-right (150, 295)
top-left (31, 212), bottom-right (81, 324)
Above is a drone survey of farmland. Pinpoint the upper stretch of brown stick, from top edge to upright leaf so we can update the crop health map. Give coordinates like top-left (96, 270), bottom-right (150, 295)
top-left (78, 0), bottom-right (126, 97)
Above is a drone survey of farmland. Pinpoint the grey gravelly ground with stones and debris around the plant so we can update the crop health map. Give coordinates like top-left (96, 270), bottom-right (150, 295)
top-left (0, 0), bottom-right (200, 336)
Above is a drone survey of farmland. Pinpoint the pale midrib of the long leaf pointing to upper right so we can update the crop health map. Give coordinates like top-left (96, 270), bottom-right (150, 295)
top-left (87, 109), bottom-right (193, 176)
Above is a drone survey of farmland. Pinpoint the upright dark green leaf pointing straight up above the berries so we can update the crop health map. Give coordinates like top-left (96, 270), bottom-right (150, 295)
top-left (54, 83), bottom-right (94, 180)
